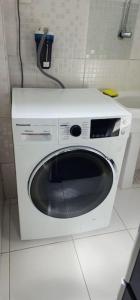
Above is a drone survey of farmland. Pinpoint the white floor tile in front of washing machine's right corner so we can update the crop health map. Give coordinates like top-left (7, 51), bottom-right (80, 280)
top-left (75, 231), bottom-right (133, 300)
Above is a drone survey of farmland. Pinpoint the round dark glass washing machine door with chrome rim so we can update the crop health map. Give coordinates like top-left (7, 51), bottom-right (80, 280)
top-left (28, 147), bottom-right (114, 218)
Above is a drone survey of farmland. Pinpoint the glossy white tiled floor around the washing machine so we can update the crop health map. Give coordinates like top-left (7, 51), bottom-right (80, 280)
top-left (0, 188), bottom-right (140, 300)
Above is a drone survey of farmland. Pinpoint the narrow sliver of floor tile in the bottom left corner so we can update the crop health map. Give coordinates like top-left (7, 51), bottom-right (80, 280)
top-left (0, 254), bottom-right (9, 300)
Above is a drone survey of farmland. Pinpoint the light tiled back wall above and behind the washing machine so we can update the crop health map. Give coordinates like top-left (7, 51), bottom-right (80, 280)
top-left (5, 0), bottom-right (140, 89)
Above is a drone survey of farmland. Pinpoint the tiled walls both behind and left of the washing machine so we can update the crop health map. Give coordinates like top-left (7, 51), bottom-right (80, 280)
top-left (0, 0), bottom-right (140, 199)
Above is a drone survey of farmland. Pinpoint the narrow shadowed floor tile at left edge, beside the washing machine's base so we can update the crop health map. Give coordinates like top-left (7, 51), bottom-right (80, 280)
top-left (1, 203), bottom-right (10, 253)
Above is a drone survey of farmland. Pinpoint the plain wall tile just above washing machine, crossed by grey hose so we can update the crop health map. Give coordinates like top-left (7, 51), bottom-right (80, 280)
top-left (23, 59), bottom-right (85, 88)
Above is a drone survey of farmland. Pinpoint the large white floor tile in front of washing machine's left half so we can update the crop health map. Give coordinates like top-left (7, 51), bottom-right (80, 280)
top-left (10, 242), bottom-right (88, 300)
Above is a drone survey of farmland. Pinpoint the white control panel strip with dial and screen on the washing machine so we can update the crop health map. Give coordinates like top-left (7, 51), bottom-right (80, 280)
top-left (15, 118), bottom-right (122, 144)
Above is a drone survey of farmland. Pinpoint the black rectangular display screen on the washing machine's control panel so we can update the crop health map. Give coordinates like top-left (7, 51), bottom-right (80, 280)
top-left (90, 118), bottom-right (121, 139)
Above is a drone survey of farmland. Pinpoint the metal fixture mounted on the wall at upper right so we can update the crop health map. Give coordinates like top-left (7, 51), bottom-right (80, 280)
top-left (118, 0), bottom-right (132, 39)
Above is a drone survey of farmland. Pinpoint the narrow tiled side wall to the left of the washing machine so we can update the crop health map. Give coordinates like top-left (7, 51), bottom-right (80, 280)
top-left (0, 1), bottom-right (15, 202)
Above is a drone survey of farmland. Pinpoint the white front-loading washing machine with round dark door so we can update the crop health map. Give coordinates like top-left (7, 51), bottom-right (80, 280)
top-left (12, 88), bottom-right (131, 239)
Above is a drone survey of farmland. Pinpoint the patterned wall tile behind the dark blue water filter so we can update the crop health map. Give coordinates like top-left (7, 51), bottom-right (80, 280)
top-left (20, 0), bottom-right (89, 59)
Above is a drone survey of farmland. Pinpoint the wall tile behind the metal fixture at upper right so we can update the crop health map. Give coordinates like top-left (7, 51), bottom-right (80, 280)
top-left (87, 0), bottom-right (139, 59)
